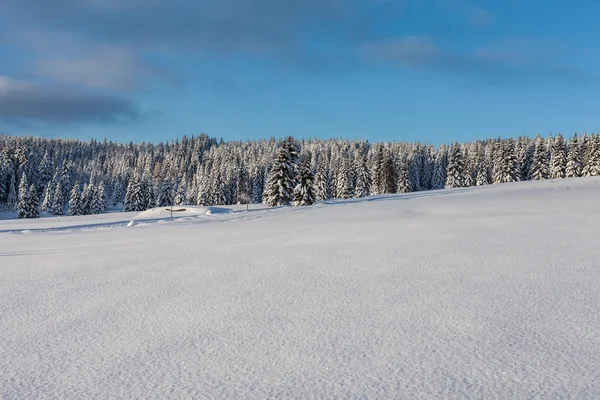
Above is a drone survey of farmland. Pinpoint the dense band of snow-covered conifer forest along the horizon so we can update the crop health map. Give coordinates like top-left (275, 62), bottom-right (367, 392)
top-left (0, 134), bottom-right (600, 218)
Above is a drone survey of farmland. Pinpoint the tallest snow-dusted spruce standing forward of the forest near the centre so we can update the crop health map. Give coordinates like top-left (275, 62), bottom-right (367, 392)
top-left (263, 137), bottom-right (298, 207)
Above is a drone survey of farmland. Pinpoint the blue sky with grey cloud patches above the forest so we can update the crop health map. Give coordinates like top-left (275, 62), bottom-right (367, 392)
top-left (0, 0), bottom-right (600, 144)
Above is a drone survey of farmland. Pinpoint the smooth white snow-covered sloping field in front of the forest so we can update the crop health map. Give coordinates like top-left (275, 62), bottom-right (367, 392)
top-left (0, 178), bottom-right (600, 399)
